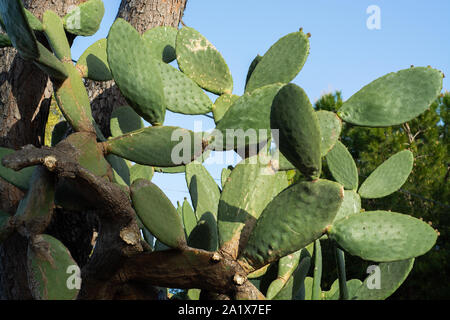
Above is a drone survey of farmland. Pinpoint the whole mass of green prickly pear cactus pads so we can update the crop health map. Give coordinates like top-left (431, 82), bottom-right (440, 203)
top-left (0, 0), bottom-right (443, 299)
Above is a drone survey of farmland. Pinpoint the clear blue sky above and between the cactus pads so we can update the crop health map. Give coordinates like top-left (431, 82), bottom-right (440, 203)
top-left (73, 0), bottom-right (450, 203)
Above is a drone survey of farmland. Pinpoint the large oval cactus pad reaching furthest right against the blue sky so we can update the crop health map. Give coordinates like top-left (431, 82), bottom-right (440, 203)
top-left (338, 67), bottom-right (443, 127)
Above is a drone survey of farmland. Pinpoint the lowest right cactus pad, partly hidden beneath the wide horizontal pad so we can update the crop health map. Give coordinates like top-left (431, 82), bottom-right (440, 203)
top-left (351, 258), bottom-right (414, 300)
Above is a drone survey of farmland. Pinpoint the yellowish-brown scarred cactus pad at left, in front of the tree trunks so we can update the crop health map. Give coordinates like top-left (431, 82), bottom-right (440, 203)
top-left (55, 63), bottom-right (95, 132)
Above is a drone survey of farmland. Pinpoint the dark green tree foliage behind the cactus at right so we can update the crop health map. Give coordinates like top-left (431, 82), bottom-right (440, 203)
top-left (315, 91), bottom-right (450, 299)
